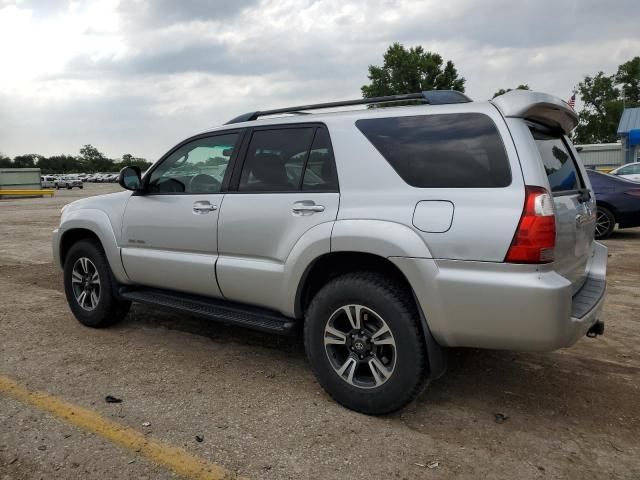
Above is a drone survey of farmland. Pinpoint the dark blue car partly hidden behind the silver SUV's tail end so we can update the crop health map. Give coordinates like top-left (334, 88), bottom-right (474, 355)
top-left (587, 170), bottom-right (640, 239)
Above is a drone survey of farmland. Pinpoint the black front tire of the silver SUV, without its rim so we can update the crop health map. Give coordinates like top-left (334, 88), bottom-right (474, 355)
top-left (64, 239), bottom-right (131, 328)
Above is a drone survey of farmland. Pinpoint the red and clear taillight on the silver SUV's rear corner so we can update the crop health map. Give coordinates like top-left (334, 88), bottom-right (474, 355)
top-left (505, 187), bottom-right (556, 263)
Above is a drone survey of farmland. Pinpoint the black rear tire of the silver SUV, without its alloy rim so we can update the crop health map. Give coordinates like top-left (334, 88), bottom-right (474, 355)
top-left (304, 272), bottom-right (427, 415)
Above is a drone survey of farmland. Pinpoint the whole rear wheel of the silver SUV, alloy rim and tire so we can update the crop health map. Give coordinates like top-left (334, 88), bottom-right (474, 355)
top-left (304, 272), bottom-right (427, 415)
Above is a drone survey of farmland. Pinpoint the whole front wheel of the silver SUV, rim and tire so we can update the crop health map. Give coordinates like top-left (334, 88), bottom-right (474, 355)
top-left (64, 240), bottom-right (131, 328)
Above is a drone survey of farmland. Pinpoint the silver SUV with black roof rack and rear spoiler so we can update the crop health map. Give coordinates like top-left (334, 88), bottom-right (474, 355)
top-left (53, 91), bottom-right (607, 414)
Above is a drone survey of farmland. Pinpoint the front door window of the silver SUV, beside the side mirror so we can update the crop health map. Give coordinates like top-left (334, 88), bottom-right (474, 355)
top-left (148, 133), bottom-right (240, 194)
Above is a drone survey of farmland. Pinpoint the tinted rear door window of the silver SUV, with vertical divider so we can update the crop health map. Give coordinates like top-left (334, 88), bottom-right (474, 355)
top-left (238, 127), bottom-right (338, 192)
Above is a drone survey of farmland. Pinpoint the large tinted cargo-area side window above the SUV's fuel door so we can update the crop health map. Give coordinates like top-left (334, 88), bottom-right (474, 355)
top-left (356, 113), bottom-right (511, 188)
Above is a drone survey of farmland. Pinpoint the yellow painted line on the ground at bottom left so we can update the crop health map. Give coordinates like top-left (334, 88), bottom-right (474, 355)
top-left (0, 375), bottom-right (239, 480)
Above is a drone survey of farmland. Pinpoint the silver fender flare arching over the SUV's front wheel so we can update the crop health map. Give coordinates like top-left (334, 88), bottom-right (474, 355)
top-left (54, 208), bottom-right (129, 283)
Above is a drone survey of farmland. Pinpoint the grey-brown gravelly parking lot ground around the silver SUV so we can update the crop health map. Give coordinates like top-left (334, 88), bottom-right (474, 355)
top-left (0, 184), bottom-right (640, 480)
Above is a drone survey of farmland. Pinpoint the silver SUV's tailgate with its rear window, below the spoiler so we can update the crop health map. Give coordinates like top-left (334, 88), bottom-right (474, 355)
top-left (528, 122), bottom-right (596, 293)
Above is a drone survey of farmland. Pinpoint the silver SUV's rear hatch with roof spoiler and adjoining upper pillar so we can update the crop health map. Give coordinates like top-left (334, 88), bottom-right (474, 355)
top-left (492, 90), bottom-right (596, 293)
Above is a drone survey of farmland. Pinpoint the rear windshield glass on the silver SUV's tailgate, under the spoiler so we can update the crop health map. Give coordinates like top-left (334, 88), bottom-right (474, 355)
top-left (531, 129), bottom-right (581, 192)
